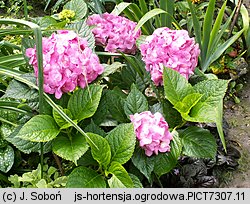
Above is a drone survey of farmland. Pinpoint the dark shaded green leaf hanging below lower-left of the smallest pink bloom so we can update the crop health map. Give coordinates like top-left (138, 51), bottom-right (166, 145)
top-left (131, 147), bottom-right (154, 182)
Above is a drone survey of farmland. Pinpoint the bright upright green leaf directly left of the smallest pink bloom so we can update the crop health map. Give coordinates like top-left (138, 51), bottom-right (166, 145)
top-left (106, 123), bottom-right (136, 164)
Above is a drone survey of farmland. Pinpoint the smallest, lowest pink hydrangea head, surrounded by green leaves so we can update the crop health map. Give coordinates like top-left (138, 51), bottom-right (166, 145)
top-left (130, 111), bottom-right (173, 156)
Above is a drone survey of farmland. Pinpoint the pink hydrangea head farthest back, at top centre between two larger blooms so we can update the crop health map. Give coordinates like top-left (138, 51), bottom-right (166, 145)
top-left (87, 13), bottom-right (141, 54)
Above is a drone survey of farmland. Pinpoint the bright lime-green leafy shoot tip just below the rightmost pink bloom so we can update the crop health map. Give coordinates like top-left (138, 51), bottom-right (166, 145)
top-left (163, 68), bottom-right (228, 150)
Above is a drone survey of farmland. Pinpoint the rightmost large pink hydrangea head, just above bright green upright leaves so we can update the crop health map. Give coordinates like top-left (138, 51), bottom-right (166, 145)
top-left (140, 27), bottom-right (200, 86)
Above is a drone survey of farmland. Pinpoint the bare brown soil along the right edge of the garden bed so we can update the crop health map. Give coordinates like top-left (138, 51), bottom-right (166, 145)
top-left (220, 0), bottom-right (250, 188)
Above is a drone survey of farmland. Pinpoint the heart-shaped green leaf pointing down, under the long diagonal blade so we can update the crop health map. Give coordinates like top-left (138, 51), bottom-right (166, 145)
top-left (52, 134), bottom-right (89, 165)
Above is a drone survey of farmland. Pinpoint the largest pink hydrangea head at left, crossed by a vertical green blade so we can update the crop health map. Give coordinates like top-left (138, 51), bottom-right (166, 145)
top-left (26, 30), bottom-right (104, 99)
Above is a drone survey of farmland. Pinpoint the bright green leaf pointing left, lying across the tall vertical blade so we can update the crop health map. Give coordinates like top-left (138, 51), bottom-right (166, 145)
top-left (17, 115), bottom-right (60, 142)
